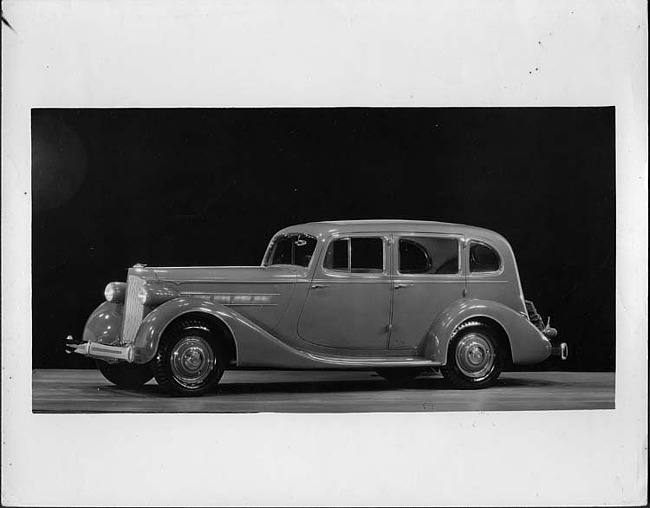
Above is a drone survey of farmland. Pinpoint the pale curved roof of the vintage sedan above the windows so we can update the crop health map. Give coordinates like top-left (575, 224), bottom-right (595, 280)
top-left (278, 219), bottom-right (502, 239)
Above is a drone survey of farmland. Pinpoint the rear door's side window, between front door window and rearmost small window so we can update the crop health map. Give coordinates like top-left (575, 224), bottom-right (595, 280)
top-left (399, 236), bottom-right (459, 275)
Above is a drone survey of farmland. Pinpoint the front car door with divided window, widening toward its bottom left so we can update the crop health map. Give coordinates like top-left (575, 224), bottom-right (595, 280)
top-left (298, 234), bottom-right (391, 350)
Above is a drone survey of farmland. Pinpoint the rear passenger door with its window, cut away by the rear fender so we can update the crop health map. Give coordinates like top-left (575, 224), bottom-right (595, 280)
top-left (390, 232), bottom-right (466, 351)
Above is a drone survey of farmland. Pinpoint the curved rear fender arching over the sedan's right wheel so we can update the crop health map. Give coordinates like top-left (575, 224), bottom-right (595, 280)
top-left (424, 298), bottom-right (551, 365)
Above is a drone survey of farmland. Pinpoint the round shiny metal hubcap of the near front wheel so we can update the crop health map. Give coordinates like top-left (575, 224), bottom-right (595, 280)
top-left (170, 335), bottom-right (216, 388)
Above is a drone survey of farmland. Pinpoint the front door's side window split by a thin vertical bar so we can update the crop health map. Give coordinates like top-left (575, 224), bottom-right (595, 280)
top-left (323, 237), bottom-right (384, 273)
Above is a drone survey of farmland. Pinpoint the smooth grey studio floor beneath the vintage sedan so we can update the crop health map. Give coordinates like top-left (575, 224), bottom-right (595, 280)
top-left (32, 369), bottom-right (615, 413)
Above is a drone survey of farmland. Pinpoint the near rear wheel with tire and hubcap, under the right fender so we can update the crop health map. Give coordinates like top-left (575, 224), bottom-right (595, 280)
top-left (440, 321), bottom-right (506, 390)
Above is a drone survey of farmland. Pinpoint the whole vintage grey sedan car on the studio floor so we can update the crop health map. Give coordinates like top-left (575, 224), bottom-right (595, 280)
top-left (68, 220), bottom-right (567, 395)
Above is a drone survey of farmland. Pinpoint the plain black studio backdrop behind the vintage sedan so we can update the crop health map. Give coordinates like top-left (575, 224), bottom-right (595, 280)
top-left (32, 108), bottom-right (615, 370)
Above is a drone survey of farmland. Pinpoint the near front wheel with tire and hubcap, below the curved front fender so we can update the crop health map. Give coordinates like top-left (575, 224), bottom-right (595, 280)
top-left (154, 319), bottom-right (226, 397)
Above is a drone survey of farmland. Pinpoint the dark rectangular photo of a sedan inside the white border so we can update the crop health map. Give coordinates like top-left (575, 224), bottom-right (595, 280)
top-left (31, 107), bottom-right (616, 413)
